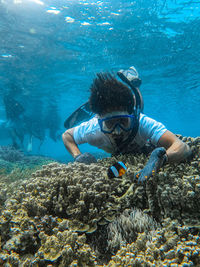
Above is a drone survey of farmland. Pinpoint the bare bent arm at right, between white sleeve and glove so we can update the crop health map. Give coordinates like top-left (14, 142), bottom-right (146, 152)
top-left (158, 131), bottom-right (191, 162)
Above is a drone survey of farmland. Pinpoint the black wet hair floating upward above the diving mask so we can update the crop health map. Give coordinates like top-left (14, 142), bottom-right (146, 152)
top-left (89, 72), bottom-right (134, 115)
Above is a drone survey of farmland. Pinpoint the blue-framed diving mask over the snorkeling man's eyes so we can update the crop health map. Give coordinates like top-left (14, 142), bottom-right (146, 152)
top-left (98, 115), bottom-right (136, 134)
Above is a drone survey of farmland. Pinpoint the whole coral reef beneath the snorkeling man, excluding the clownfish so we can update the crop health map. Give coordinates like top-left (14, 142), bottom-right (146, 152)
top-left (0, 136), bottom-right (200, 266)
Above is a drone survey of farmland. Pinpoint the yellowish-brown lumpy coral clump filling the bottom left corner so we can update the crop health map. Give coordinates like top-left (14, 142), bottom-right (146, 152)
top-left (0, 205), bottom-right (96, 266)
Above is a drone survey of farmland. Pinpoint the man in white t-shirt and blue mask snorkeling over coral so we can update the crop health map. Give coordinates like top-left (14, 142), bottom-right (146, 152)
top-left (63, 68), bottom-right (191, 182)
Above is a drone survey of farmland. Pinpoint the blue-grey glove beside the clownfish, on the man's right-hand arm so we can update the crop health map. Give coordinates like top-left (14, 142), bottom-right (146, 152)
top-left (136, 147), bottom-right (167, 183)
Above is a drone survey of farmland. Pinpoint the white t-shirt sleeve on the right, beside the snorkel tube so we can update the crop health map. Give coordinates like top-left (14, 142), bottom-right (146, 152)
top-left (139, 114), bottom-right (167, 145)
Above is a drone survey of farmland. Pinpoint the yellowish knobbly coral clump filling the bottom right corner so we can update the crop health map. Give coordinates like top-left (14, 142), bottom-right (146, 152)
top-left (106, 219), bottom-right (200, 267)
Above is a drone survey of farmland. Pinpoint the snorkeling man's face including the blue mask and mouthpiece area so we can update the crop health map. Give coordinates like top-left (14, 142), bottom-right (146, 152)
top-left (99, 111), bottom-right (133, 143)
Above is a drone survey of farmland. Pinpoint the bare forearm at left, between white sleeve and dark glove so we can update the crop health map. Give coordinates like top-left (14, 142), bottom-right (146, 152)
top-left (62, 128), bottom-right (81, 158)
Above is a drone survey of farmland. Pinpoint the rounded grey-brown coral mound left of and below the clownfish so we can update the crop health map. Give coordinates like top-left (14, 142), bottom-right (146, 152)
top-left (23, 163), bottom-right (121, 233)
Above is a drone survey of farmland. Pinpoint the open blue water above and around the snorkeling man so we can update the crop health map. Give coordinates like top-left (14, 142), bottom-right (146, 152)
top-left (0, 0), bottom-right (200, 160)
